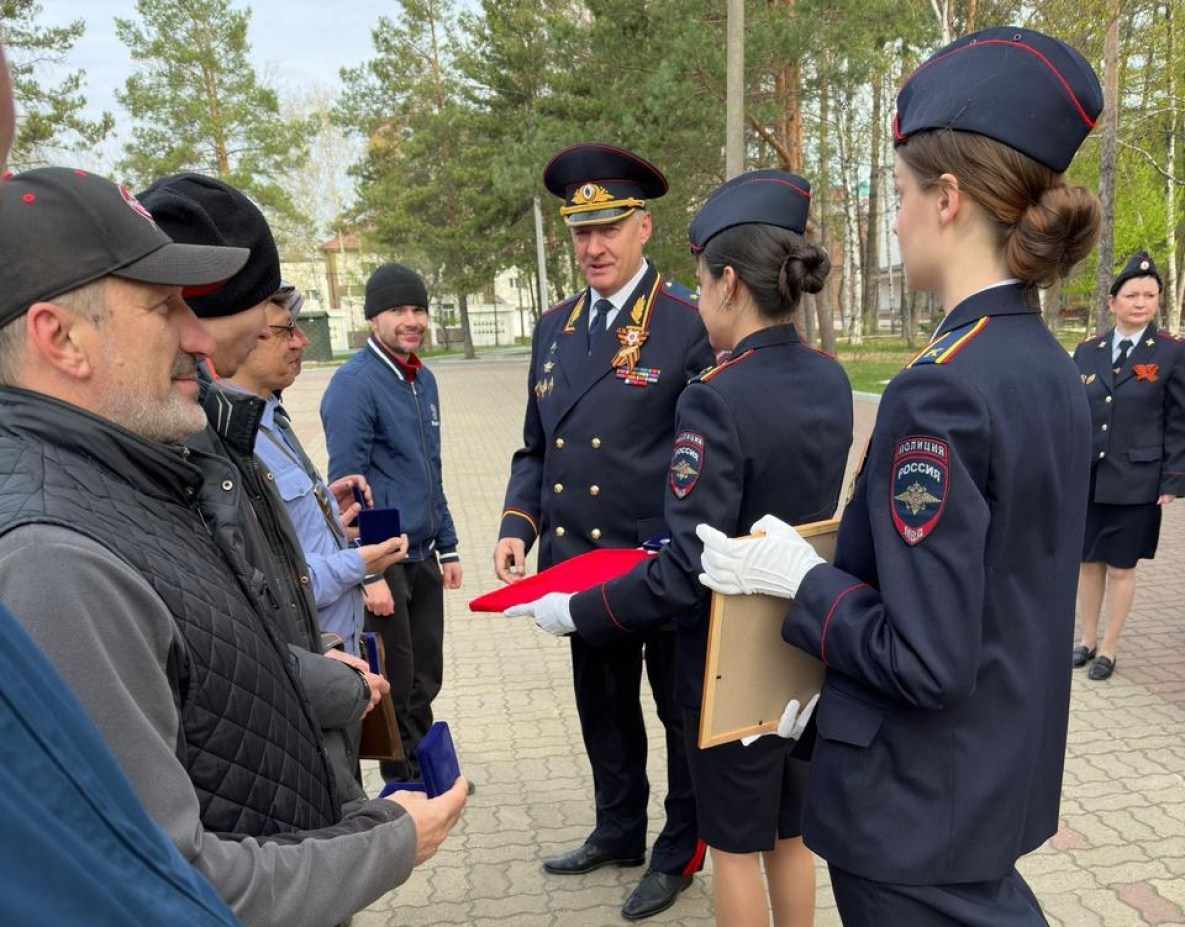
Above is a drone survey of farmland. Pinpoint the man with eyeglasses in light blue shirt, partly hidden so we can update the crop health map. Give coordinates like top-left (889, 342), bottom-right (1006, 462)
top-left (224, 285), bottom-right (408, 656)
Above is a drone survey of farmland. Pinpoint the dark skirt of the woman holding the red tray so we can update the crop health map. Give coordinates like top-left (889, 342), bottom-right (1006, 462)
top-left (684, 708), bottom-right (811, 854)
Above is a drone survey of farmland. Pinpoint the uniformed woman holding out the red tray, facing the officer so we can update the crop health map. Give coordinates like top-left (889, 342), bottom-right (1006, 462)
top-left (507, 171), bottom-right (852, 927)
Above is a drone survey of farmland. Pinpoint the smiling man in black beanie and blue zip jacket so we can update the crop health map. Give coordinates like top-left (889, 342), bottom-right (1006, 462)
top-left (321, 264), bottom-right (461, 781)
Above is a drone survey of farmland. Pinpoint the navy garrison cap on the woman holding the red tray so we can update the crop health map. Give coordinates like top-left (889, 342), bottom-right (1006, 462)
top-left (687, 170), bottom-right (811, 254)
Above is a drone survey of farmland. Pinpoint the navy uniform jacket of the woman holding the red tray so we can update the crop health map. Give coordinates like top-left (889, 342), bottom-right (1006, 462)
top-left (571, 325), bottom-right (852, 708)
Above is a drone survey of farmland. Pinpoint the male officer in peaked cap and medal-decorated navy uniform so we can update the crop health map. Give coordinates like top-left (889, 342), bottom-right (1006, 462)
top-left (494, 143), bottom-right (713, 919)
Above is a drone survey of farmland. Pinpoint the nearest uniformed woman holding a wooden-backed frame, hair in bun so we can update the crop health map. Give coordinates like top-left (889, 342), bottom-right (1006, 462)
top-left (699, 27), bottom-right (1102, 927)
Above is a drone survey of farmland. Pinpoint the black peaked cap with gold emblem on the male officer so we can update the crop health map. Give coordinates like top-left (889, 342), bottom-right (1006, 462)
top-left (543, 142), bottom-right (667, 229)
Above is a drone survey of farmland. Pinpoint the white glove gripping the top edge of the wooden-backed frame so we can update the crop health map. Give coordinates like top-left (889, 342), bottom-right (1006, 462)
top-left (696, 514), bottom-right (826, 599)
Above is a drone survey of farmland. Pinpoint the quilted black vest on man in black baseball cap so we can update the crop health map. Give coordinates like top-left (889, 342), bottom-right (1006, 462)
top-left (0, 389), bottom-right (340, 837)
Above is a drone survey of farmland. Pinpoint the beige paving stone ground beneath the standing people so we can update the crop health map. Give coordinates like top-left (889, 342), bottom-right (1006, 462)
top-left (286, 351), bottom-right (1185, 927)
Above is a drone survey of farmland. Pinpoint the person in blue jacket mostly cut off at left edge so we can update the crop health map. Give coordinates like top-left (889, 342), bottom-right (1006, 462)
top-left (0, 52), bottom-right (238, 927)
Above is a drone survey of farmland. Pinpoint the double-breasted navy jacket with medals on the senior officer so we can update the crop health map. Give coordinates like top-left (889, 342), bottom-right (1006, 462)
top-left (499, 264), bottom-right (715, 570)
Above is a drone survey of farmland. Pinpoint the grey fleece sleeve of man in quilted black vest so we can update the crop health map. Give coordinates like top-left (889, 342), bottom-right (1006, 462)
top-left (0, 525), bottom-right (416, 927)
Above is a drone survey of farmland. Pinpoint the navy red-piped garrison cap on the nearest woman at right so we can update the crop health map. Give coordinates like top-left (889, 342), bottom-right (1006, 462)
top-left (893, 26), bottom-right (1103, 173)
